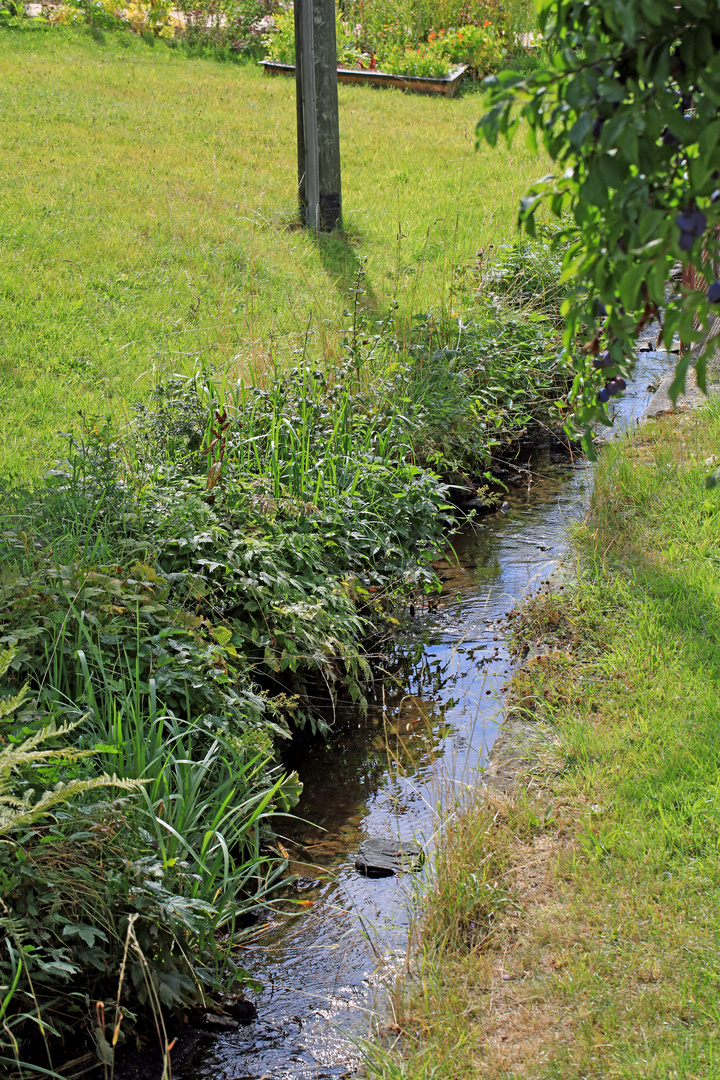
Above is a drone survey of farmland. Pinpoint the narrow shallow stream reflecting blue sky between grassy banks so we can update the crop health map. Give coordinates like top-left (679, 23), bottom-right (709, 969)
top-left (180, 352), bottom-right (669, 1080)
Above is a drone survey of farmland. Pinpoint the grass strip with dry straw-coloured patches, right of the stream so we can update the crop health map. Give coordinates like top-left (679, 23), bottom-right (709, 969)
top-left (376, 405), bottom-right (720, 1080)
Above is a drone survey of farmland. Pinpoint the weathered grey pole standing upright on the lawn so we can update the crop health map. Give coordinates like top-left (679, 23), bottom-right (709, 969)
top-left (295, 0), bottom-right (342, 232)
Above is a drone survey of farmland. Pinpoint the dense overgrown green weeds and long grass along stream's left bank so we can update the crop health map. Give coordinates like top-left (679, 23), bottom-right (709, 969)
top-left (0, 291), bottom-right (574, 1069)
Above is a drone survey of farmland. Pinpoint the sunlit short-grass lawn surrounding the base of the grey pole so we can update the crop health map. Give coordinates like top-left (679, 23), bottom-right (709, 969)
top-left (0, 29), bottom-right (543, 477)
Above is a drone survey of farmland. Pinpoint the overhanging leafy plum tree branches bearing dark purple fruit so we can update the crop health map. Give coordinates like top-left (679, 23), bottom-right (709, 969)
top-left (478, 0), bottom-right (720, 453)
